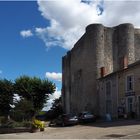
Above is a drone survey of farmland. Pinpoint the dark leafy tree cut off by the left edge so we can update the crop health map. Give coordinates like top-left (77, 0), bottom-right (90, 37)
top-left (0, 79), bottom-right (13, 117)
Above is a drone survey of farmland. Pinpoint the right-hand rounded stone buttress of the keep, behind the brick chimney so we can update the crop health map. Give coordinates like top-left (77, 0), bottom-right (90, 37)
top-left (117, 24), bottom-right (135, 70)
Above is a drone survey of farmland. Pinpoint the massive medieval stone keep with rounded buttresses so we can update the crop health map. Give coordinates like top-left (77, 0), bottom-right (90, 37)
top-left (62, 23), bottom-right (140, 115)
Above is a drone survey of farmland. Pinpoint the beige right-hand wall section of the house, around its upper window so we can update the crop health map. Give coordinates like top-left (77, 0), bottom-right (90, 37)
top-left (118, 62), bottom-right (140, 116)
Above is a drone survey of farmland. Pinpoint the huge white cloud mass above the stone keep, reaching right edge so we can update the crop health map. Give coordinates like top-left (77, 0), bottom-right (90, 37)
top-left (36, 0), bottom-right (140, 49)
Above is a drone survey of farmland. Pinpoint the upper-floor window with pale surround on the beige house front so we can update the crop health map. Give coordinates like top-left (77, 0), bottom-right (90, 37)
top-left (126, 75), bottom-right (134, 91)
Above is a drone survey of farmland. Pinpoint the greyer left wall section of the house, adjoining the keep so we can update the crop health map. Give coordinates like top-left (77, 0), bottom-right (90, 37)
top-left (98, 74), bottom-right (118, 118)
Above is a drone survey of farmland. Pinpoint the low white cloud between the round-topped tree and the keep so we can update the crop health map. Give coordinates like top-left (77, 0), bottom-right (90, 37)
top-left (43, 87), bottom-right (61, 111)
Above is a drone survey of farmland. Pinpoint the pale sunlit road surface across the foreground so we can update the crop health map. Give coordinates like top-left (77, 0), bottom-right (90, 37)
top-left (0, 120), bottom-right (140, 139)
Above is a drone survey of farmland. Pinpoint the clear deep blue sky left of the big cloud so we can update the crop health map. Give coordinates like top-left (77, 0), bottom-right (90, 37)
top-left (0, 1), bottom-right (67, 90)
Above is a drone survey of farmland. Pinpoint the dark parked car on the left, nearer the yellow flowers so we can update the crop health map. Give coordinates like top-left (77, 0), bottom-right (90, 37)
top-left (49, 114), bottom-right (78, 126)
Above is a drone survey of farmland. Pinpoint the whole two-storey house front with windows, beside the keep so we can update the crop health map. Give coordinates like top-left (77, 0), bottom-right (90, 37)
top-left (98, 61), bottom-right (140, 118)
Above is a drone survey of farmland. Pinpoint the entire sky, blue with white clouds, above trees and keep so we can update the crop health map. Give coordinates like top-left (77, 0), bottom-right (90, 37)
top-left (0, 0), bottom-right (140, 109)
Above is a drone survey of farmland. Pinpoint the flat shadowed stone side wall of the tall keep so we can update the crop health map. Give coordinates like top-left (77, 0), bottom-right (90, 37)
top-left (70, 28), bottom-right (98, 114)
